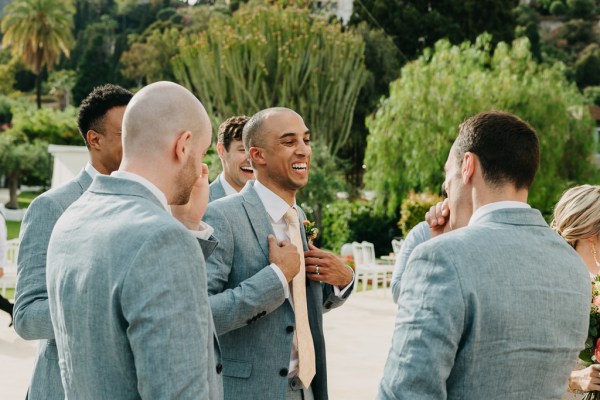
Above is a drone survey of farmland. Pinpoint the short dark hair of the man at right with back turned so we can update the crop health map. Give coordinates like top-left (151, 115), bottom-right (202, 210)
top-left (455, 112), bottom-right (540, 189)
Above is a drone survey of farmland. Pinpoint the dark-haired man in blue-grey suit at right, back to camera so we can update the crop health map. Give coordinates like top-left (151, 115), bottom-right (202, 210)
top-left (378, 112), bottom-right (590, 400)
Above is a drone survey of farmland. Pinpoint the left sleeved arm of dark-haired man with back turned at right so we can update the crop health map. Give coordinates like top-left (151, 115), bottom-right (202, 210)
top-left (377, 245), bottom-right (466, 400)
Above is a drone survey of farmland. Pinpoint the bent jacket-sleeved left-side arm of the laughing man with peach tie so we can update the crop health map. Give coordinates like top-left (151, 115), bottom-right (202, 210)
top-left (204, 207), bottom-right (285, 335)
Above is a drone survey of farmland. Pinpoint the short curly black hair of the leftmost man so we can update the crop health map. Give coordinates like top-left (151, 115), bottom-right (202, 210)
top-left (77, 83), bottom-right (133, 146)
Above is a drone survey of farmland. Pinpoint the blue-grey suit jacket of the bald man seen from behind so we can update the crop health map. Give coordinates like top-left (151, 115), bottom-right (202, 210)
top-left (47, 176), bottom-right (223, 400)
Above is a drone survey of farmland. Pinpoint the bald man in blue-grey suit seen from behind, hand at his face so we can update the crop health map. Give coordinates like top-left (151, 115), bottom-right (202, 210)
top-left (47, 82), bottom-right (223, 400)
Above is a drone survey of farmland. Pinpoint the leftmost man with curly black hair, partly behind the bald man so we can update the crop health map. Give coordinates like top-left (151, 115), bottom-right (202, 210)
top-left (14, 85), bottom-right (133, 400)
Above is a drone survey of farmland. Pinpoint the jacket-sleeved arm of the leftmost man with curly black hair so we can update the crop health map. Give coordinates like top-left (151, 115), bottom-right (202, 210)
top-left (14, 196), bottom-right (64, 340)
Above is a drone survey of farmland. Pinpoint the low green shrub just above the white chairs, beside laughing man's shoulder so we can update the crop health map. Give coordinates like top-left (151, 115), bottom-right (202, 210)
top-left (320, 200), bottom-right (398, 255)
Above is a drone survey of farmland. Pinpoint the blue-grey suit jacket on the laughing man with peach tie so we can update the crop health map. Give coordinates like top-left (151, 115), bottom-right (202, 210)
top-left (204, 181), bottom-right (351, 400)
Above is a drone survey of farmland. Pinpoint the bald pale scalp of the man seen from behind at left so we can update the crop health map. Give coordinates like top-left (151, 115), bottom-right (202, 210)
top-left (123, 82), bottom-right (211, 160)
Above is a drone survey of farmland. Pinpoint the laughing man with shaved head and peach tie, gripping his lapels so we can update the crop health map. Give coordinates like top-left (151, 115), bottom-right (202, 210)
top-left (204, 108), bottom-right (354, 400)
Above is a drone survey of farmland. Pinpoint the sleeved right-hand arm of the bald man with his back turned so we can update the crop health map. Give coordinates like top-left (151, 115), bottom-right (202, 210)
top-left (121, 229), bottom-right (214, 399)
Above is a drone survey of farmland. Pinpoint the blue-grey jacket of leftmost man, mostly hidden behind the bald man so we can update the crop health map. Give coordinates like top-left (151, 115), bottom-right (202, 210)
top-left (14, 170), bottom-right (92, 400)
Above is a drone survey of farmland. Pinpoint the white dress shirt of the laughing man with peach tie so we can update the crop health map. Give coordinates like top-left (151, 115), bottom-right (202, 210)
top-left (254, 180), bottom-right (354, 377)
